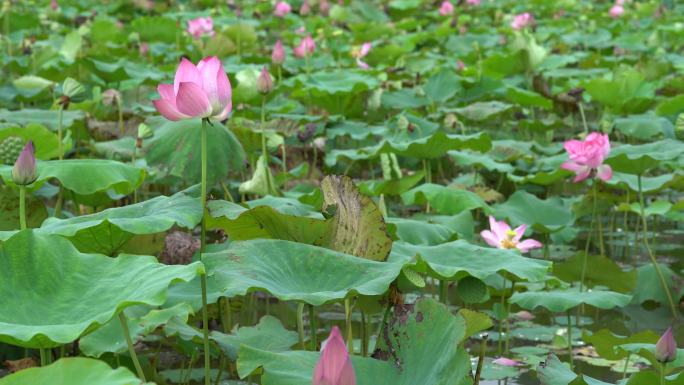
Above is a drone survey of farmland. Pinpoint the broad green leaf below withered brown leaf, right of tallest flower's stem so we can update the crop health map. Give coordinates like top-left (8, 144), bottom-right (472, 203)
top-left (195, 239), bottom-right (402, 306)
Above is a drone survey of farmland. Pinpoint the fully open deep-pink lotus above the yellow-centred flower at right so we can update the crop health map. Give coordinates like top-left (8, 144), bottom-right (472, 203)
top-left (561, 132), bottom-right (613, 182)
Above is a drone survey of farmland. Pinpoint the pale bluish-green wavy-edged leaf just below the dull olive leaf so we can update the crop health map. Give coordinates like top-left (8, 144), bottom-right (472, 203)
top-left (510, 287), bottom-right (632, 313)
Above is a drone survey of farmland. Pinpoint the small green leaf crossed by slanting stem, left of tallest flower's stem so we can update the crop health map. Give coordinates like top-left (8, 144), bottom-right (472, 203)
top-left (78, 303), bottom-right (192, 358)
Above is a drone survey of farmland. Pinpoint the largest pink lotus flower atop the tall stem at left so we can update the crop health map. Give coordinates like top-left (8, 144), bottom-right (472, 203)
top-left (152, 56), bottom-right (233, 121)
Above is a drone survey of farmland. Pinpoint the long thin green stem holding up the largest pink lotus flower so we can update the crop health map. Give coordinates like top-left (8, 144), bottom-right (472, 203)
top-left (200, 119), bottom-right (211, 385)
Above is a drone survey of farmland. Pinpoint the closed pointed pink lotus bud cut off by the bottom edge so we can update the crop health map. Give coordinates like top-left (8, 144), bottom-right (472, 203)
top-left (312, 326), bottom-right (356, 385)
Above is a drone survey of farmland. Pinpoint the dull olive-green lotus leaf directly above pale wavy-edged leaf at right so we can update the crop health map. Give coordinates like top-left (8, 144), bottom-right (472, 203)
top-left (553, 253), bottom-right (637, 293)
